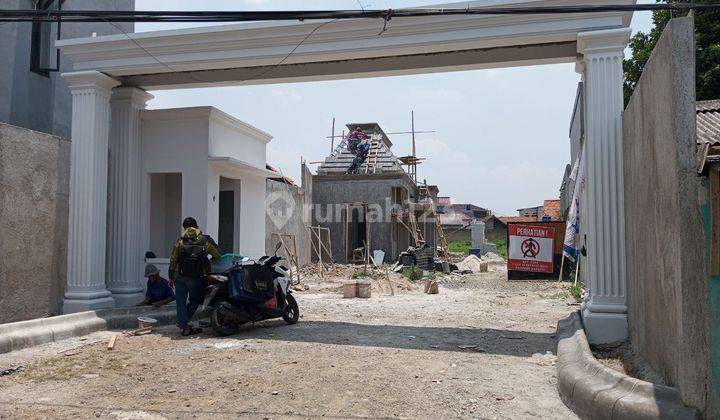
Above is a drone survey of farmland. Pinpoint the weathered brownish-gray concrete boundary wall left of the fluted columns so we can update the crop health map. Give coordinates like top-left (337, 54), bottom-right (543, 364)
top-left (0, 123), bottom-right (70, 323)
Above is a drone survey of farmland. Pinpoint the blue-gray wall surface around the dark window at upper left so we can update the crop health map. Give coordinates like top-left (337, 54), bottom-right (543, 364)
top-left (0, 0), bottom-right (135, 138)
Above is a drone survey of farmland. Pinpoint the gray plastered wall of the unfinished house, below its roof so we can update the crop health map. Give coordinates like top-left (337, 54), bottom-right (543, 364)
top-left (313, 174), bottom-right (420, 262)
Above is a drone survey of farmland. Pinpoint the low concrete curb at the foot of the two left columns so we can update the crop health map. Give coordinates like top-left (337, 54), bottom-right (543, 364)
top-left (0, 305), bottom-right (209, 354)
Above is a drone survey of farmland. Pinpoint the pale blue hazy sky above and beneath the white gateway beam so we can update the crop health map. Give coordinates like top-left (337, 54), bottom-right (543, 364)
top-left (136, 0), bottom-right (651, 215)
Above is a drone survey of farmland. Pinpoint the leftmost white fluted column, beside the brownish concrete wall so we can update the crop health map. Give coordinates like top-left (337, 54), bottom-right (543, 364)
top-left (62, 71), bottom-right (119, 313)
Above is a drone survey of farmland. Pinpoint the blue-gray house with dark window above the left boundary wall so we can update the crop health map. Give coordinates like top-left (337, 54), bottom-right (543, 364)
top-left (0, 0), bottom-right (135, 139)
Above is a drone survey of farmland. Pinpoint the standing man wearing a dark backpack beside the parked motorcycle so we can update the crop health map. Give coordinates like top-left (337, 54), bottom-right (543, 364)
top-left (168, 217), bottom-right (220, 336)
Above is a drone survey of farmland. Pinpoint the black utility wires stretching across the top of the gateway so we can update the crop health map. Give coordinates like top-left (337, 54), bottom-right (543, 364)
top-left (0, 3), bottom-right (720, 22)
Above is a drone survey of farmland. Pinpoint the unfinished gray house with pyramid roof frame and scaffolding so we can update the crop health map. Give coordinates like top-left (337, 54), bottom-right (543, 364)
top-left (312, 123), bottom-right (437, 264)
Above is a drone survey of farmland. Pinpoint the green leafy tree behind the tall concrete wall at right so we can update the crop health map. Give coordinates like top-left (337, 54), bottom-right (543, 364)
top-left (623, 0), bottom-right (720, 104)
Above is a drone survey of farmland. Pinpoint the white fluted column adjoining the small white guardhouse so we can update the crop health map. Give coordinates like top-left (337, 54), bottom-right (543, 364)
top-left (106, 87), bottom-right (153, 307)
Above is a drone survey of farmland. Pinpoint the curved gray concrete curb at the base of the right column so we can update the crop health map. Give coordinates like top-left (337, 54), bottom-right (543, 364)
top-left (556, 312), bottom-right (701, 419)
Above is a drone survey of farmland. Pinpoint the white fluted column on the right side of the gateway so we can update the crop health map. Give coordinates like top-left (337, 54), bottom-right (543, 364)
top-left (578, 28), bottom-right (630, 343)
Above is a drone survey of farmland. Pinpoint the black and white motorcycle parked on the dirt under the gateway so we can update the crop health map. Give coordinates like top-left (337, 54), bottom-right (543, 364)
top-left (203, 243), bottom-right (300, 336)
